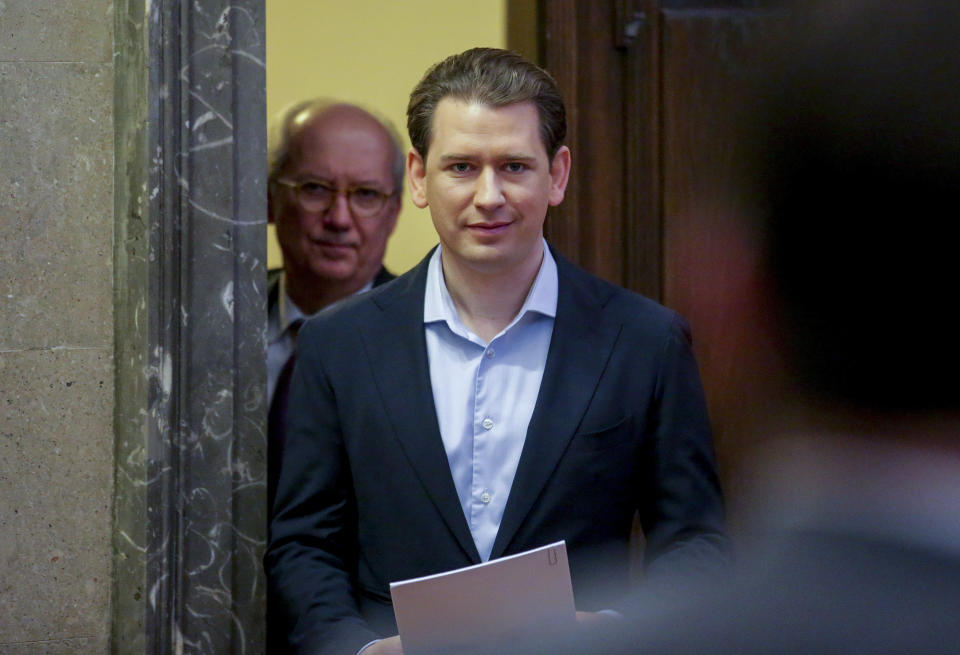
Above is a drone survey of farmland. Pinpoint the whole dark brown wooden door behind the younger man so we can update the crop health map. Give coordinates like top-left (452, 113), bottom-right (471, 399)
top-left (539, 0), bottom-right (777, 523)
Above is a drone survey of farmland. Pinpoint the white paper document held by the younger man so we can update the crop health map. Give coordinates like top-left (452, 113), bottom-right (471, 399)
top-left (390, 541), bottom-right (576, 655)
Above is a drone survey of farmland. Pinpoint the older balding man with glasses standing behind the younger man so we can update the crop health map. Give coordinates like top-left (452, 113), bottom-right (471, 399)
top-left (267, 98), bottom-right (404, 507)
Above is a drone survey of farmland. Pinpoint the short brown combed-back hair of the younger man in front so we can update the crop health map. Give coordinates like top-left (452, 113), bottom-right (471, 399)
top-left (407, 48), bottom-right (567, 160)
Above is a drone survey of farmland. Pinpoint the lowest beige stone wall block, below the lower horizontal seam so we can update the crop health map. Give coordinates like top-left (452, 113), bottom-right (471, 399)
top-left (0, 348), bottom-right (113, 653)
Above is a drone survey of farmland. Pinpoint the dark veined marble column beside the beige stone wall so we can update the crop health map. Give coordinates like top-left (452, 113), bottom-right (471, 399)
top-left (112, 0), bottom-right (266, 655)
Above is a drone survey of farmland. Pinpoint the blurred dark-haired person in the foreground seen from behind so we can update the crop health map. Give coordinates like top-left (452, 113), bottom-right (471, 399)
top-left (532, 0), bottom-right (960, 655)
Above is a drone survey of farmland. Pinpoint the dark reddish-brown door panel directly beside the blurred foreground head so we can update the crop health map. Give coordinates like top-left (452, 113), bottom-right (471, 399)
top-left (661, 7), bottom-right (780, 510)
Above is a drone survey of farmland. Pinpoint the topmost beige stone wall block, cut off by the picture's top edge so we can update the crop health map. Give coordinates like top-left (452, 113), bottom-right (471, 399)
top-left (0, 0), bottom-right (113, 63)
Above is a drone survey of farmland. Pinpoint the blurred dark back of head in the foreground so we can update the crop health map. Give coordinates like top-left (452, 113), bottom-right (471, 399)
top-left (753, 0), bottom-right (960, 411)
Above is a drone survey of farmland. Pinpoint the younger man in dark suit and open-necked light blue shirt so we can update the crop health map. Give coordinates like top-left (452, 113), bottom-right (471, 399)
top-left (266, 48), bottom-right (726, 655)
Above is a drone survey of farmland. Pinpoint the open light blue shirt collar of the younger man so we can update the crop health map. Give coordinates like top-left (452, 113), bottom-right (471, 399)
top-left (423, 239), bottom-right (558, 332)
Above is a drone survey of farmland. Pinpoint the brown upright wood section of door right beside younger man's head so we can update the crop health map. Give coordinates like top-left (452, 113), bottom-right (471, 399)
top-left (542, 0), bottom-right (653, 292)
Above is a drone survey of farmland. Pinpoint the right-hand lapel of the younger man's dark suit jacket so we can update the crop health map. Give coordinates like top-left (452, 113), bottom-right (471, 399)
top-left (491, 252), bottom-right (620, 559)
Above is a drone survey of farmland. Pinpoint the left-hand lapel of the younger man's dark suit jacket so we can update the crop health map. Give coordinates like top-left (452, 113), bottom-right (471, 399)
top-left (362, 255), bottom-right (480, 562)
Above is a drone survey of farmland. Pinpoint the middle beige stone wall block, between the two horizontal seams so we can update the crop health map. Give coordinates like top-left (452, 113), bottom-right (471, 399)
top-left (0, 61), bottom-right (113, 350)
